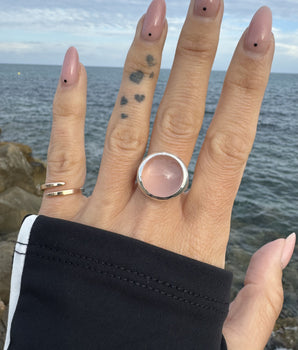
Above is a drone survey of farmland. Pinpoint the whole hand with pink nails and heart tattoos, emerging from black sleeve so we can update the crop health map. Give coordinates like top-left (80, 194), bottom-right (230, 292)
top-left (40, 0), bottom-right (295, 350)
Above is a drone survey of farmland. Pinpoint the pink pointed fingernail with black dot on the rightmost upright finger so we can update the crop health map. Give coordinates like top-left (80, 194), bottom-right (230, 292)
top-left (244, 6), bottom-right (272, 54)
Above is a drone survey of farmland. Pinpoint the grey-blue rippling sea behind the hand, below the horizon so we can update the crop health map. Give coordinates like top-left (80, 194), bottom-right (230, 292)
top-left (0, 64), bottom-right (298, 349)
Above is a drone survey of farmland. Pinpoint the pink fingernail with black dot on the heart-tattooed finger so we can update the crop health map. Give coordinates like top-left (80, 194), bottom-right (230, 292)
top-left (141, 0), bottom-right (166, 41)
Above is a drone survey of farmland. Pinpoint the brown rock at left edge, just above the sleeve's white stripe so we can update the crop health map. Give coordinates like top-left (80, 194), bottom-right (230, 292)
top-left (0, 186), bottom-right (42, 235)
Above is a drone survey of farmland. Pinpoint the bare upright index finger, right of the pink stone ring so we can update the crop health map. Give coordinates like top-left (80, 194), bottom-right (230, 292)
top-left (187, 7), bottom-right (274, 232)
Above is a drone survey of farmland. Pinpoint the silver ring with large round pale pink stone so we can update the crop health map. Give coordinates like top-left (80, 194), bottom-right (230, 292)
top-left (137, 152), bottom-right (189, 200)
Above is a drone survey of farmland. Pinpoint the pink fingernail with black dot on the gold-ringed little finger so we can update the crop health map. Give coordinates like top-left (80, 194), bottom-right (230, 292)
top-left (61, 47), bottom-right (80, 86)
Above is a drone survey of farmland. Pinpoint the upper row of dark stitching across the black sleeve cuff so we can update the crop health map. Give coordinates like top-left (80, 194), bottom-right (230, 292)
top-left (17, 242), bottom-right (229, 306)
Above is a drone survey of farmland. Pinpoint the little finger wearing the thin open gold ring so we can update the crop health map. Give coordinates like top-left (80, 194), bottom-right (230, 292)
top-left (40, 47), bottom-right (87, 218)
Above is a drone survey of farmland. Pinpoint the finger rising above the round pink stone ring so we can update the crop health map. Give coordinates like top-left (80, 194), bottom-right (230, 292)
top-left (149, 0), bottom-right (223, 164)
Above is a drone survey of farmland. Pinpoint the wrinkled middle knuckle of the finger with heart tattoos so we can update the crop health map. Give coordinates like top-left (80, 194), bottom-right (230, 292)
top-left (106, 123), bottom-right (147, 154)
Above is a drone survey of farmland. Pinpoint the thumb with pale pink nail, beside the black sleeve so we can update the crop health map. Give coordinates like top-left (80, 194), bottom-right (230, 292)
top-left (223, 233), bottom-right (296, 350)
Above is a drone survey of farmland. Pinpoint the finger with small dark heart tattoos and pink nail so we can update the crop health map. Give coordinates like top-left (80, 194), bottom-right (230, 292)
top-left (91, 0), bottom-right (167, 208)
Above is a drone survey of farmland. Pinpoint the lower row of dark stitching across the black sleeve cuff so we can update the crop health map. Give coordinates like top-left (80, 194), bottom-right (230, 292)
top-left (26, 251), bottom-right (226, 315)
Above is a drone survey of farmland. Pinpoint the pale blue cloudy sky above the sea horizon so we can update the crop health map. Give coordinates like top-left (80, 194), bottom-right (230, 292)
top-left (0, 0), bottom-right (298, 73)
